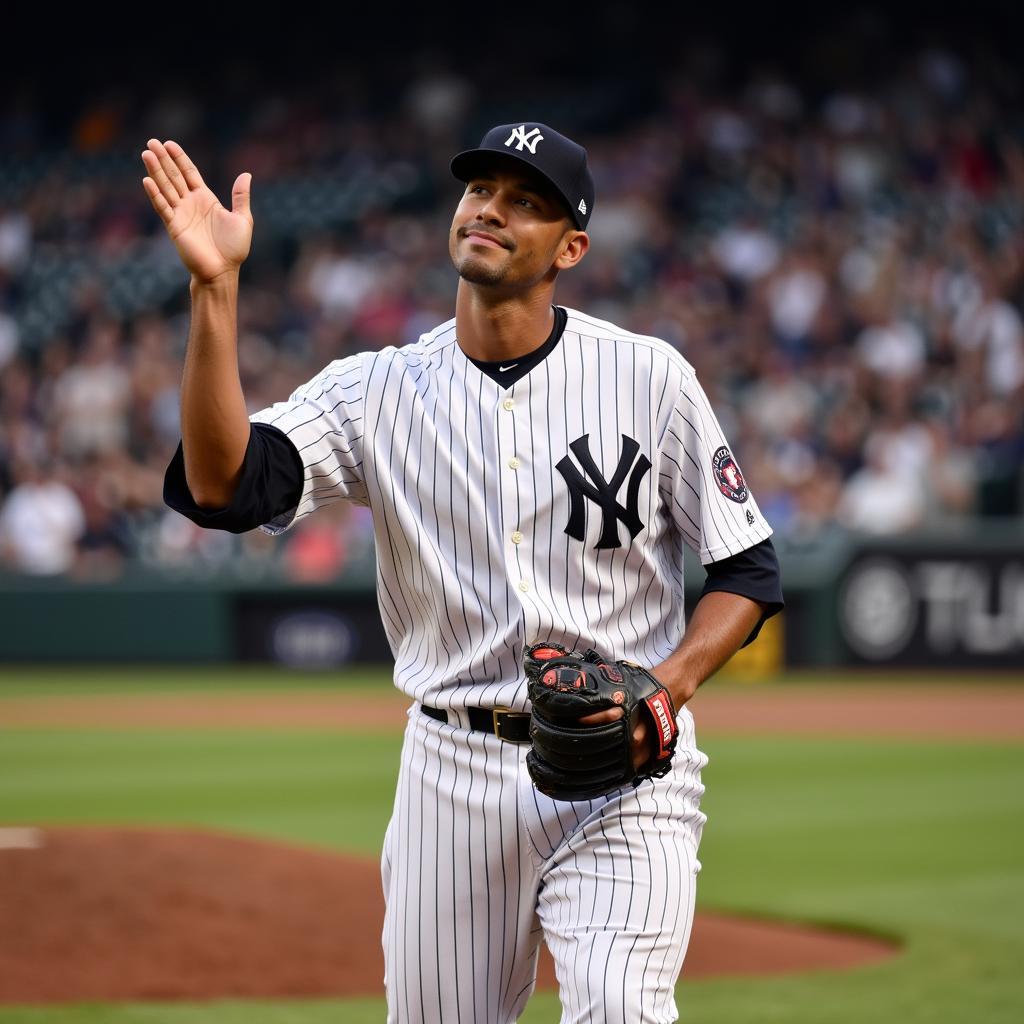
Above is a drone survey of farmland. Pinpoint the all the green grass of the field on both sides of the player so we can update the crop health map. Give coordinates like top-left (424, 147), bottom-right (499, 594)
top-left (0, 670), bottom-right (1024, 1024)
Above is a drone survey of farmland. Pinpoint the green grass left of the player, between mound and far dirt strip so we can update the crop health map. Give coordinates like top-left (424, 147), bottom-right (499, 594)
top-left (0, 729), bottom-right (401, 854)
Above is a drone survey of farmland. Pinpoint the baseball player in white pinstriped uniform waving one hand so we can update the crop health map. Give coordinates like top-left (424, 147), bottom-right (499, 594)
top-left (142, 122), bottom-right (782, 1024)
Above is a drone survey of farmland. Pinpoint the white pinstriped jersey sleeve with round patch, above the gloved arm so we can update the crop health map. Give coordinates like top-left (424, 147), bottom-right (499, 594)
top-left (659, 373), bottom-right (772, 565)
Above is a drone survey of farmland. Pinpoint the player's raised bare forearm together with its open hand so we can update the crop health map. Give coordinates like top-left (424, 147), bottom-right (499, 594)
top-left (142, 139), bottom-right (253, 508)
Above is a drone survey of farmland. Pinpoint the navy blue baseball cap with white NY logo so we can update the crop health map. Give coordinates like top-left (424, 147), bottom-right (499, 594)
top-left (451, 121), bottom-right (594, 231)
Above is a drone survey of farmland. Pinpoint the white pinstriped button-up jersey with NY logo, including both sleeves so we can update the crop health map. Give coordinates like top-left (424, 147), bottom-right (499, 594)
top-left (250, 308), bottom-right (772, 710)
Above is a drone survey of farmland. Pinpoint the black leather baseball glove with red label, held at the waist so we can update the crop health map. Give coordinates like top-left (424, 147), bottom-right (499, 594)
top-left (523, 643), bottom-right (679, 800)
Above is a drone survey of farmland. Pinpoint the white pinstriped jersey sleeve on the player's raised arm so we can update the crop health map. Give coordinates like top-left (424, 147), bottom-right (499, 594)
top-left (249, 354), bottom-right (370, 535)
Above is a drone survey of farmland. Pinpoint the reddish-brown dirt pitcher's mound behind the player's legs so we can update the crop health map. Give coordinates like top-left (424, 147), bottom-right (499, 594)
top-left (0, 828), bottom-right (892, 1002)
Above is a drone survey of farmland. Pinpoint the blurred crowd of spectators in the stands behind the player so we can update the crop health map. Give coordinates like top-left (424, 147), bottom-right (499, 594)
top-left (0, 39), bottom-right (1024, 580)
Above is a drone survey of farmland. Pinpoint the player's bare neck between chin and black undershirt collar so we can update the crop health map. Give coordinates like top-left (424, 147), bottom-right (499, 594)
top-left (455, 281), bottom-right (555, 362)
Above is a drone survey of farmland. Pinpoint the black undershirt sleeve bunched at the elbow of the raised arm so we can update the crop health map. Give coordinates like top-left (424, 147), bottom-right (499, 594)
top-left (164, 423), bottom-right (305, 534)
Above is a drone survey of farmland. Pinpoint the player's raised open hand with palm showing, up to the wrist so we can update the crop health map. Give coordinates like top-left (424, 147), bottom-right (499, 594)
top-left (142, 138), bottom-right (253, 284)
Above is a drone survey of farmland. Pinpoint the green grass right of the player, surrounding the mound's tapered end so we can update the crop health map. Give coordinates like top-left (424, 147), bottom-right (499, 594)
top-left (681, 738), bottom-right (1024, 1024)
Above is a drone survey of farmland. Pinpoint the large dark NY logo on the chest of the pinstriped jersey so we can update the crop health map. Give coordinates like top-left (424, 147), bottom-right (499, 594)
top-left (555, 434), bottom-right (650, 548)
